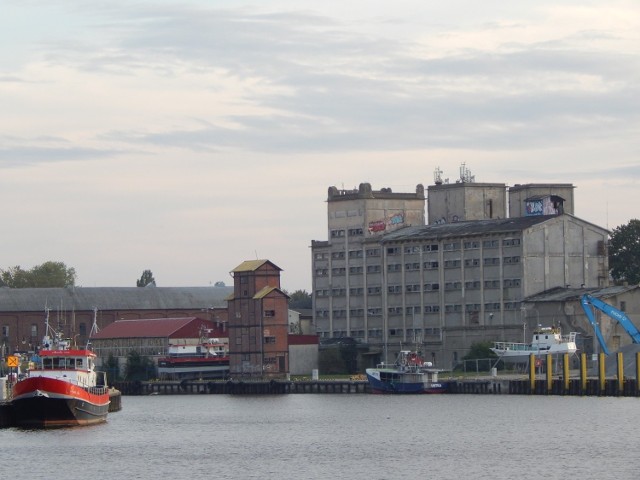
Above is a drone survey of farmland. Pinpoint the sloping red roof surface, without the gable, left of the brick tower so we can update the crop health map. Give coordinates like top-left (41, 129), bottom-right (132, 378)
top-left (91, 317), bottom-right (219, 340)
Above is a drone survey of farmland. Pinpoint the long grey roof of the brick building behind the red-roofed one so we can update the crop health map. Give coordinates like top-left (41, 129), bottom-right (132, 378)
top-left (0, 287), bottom-right (233, 312)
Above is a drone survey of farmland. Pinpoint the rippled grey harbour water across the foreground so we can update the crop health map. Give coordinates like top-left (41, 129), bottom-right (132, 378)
top-left (0, 394), bottom-right (640, 480)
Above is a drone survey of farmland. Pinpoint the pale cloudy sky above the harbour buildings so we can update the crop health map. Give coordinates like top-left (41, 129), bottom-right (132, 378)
top-left (0, 0), bottom-right (640, 292)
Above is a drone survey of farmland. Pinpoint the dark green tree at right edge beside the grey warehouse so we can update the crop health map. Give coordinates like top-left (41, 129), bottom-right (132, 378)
top-left (609, 219), bottom-right (640, 284)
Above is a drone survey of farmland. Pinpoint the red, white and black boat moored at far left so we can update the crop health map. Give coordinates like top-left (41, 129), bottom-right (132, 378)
top-left (11, 312), bottom-right (110, 428)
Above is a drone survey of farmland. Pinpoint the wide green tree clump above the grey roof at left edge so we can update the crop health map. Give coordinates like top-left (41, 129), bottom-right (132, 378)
top-left (0, 261), bottom-right (76, 288)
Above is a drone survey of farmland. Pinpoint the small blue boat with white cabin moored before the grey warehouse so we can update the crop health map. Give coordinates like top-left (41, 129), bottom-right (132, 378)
top-left (366, 350), bottom-right (447, 394)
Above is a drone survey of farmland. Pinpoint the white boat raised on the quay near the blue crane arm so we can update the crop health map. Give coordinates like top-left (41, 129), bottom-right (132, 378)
top-left (491, 327), bottom-right (578, 363)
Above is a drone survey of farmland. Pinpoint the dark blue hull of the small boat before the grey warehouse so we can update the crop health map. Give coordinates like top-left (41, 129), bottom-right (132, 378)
top-left (366, 368), bottom-right (447, 394)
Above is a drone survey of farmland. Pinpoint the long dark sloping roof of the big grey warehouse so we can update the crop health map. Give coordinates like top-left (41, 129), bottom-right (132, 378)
top-left (382, 215), bottom-right (558, 243)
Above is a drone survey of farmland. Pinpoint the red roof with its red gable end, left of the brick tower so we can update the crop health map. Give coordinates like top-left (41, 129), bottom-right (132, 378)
top-left (91, 317), bottom-right (228, 339)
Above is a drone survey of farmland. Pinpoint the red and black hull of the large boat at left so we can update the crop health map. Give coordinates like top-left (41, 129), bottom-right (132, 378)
top-left (11, 377), bottom-right (110, 428)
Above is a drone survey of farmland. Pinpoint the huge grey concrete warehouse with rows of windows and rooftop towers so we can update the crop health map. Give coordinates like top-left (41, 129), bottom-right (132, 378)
top-left (312, 176), bottom-right (608, 366)
